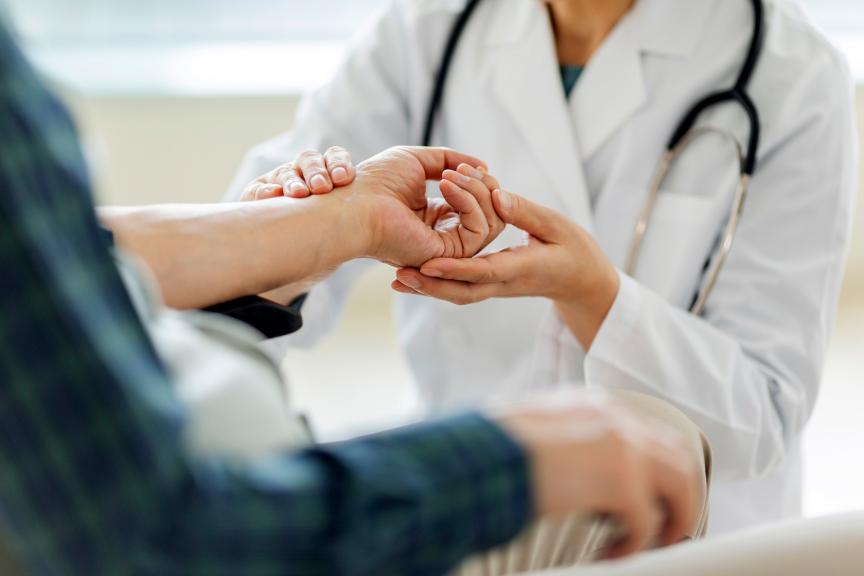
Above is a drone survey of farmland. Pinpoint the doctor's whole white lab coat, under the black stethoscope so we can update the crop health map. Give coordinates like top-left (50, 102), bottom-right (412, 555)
top-left (232, 0), bottom-right (857, 533)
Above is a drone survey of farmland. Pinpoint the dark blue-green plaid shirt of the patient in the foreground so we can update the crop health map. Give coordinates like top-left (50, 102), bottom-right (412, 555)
top-left (0, 26), bottom-right (531, 576)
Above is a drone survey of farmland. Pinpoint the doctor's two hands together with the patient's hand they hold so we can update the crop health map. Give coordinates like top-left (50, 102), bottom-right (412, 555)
top-left (242, 147), bottom-right (619, 350)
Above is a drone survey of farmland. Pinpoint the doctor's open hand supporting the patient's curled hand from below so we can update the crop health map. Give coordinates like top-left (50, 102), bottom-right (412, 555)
top-left (393, 190), bottom-right (620, 350)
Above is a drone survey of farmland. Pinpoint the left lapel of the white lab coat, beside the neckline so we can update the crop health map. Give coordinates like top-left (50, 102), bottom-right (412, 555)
top-left (488, 0), bottom-right (593, 231)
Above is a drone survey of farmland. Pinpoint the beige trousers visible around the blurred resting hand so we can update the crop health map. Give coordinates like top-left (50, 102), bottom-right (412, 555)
top-left (453, 392), bottom-right (711, 576)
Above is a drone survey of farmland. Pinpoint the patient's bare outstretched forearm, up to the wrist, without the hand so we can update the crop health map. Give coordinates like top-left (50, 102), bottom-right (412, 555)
top-left (100, 194), bottom-right (367, 308)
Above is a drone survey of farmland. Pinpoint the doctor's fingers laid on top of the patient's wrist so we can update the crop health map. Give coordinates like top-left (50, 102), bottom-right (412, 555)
top-left (240, 146), bottom-right (357, 202)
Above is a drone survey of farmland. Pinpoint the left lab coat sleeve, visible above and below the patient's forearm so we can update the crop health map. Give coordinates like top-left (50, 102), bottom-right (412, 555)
top-left (225, 2), bottom-right (426, 355)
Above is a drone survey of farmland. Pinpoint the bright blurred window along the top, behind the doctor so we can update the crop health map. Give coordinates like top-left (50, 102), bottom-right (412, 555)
top-left (5, 0), bottom-right (864, 94)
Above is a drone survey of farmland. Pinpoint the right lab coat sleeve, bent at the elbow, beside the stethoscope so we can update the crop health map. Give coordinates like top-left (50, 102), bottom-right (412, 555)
top-left (585, 46), bottom-right (857, 480)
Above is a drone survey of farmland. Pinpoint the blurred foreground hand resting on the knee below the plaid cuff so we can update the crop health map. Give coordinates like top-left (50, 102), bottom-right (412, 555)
top-left (499, 394), bottom-right (700, 558)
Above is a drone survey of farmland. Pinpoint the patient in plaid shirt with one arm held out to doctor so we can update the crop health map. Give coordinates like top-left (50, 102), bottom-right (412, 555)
top-left (0, 29), bottom-right (699, 575)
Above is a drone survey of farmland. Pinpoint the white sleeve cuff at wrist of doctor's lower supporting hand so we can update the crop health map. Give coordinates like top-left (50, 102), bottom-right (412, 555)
top-left (585, 271), bottom-right (642, 372)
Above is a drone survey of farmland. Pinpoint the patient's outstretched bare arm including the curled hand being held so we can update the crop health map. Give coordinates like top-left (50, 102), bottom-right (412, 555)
top-left (101, 148), bottom-right (488, 308)
